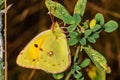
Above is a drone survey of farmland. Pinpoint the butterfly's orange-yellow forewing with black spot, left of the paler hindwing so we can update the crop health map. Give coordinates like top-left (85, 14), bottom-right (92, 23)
top-left (16, 30), bottom-right (51, 69)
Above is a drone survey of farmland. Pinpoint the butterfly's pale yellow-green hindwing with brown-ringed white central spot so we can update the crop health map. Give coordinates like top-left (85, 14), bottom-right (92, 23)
top-left (39, 30), bottom-right (70, 73)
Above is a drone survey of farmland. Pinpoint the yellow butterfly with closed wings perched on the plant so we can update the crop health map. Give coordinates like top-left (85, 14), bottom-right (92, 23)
top-left (16, 22), bottom-right (71, 74)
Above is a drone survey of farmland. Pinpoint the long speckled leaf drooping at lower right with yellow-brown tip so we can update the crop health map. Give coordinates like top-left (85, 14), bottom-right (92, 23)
top-left (83, 47), bottom-right (111, 73)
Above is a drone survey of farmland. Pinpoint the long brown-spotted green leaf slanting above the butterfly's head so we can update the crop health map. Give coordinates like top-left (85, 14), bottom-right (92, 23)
top-left (45, 0), bottom-right (75, 24)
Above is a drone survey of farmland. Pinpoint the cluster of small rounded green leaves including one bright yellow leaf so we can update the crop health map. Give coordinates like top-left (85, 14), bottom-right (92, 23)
top-left (68, 13), bottom-right (118, 46)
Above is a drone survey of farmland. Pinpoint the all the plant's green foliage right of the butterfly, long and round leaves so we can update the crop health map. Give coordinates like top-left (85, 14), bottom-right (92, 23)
top-left (46, 0), bottom-right (118, 80)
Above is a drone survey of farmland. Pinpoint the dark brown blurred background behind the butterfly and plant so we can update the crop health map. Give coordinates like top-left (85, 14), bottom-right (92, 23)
top-left (7, 0), bottom-right (120, 80)
